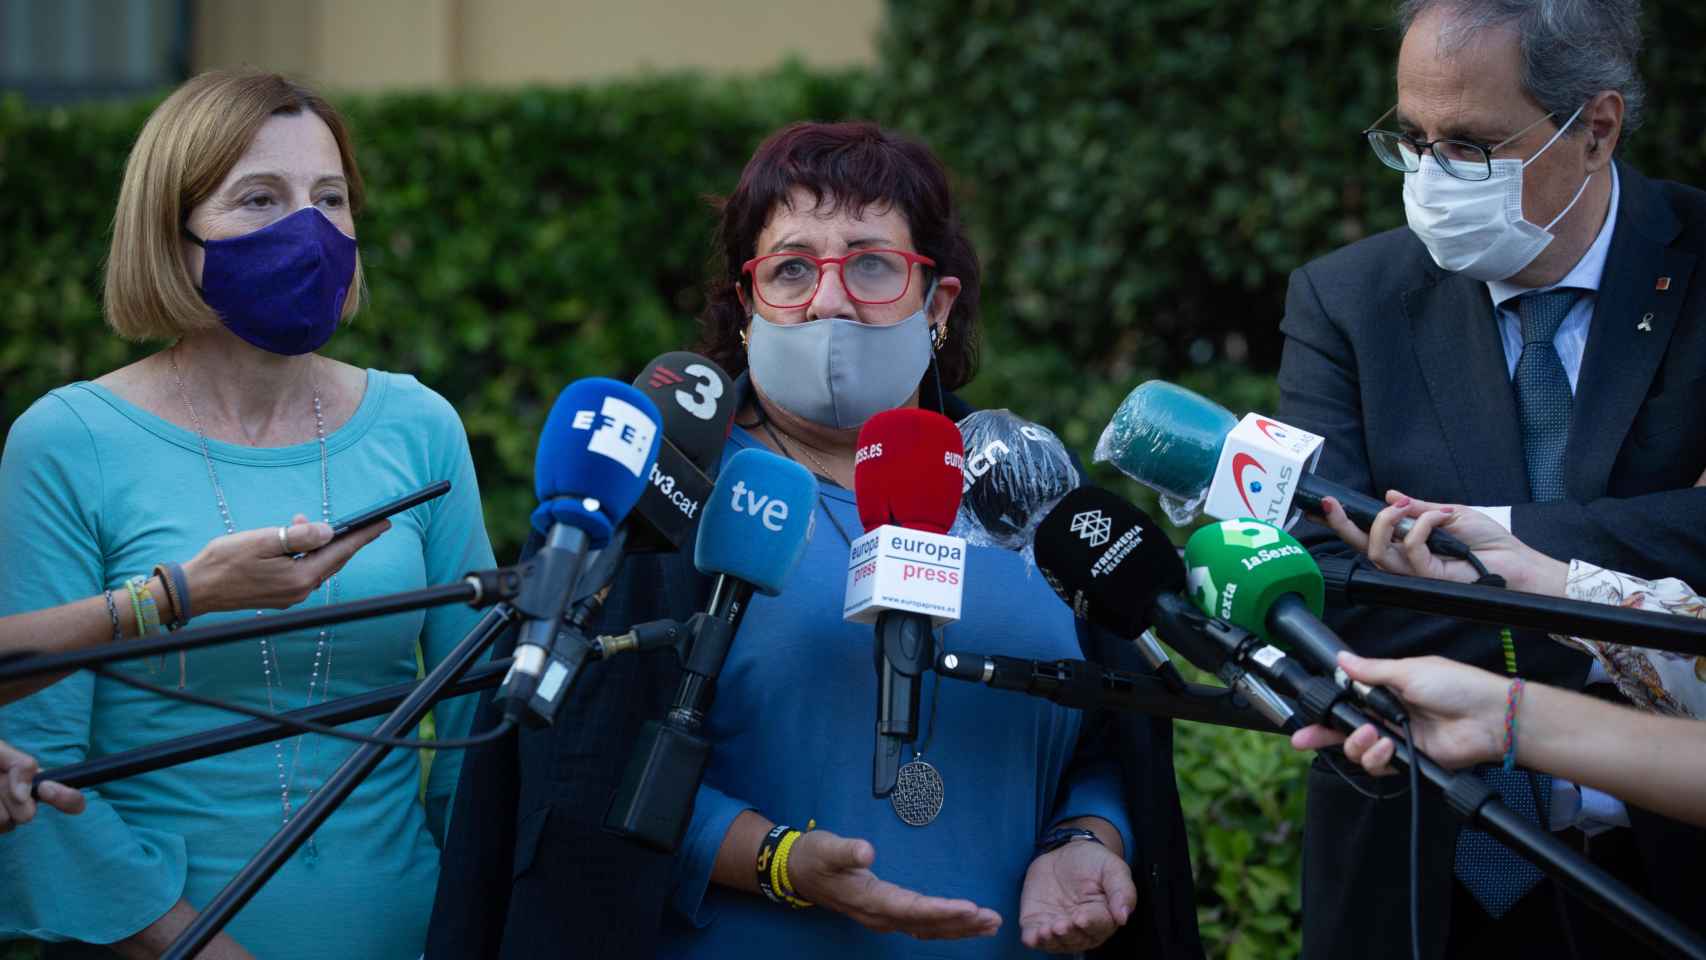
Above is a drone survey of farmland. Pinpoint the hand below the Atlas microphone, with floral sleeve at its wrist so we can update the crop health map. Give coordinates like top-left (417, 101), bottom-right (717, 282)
top-left (1320, 489), bottom-right (1570, 597)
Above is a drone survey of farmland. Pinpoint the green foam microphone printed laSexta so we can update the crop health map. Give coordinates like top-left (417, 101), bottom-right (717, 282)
top-left (1184, 520), bottom-right (1406, 723)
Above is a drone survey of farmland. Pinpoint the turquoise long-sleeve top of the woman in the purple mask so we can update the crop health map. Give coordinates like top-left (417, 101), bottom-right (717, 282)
top-left (0, 370), bottom-right (493, 960)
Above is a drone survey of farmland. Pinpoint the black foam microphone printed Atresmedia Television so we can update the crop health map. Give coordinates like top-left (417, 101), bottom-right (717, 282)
top-left (1037, 486), bottom-right (1184, 692)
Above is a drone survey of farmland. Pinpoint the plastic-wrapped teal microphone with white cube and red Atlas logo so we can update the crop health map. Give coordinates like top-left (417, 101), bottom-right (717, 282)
top-left (1095, 380), bottom-right (1471, 559)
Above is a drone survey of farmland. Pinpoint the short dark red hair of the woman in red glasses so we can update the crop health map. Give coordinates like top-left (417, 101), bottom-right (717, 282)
top-left (694, 123), bottom-right (979, 390)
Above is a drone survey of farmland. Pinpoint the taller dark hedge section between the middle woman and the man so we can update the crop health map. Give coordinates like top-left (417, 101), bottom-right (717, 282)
top-left (880, 0), bottom-right (1706, 375)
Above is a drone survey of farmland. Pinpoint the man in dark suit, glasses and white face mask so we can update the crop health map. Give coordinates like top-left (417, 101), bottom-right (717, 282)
top-left (1280, 0), bottom-right (1706, 960)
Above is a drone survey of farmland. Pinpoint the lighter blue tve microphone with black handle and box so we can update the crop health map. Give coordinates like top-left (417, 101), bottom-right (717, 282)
top-left (604, 450), bottom-right (817, 853)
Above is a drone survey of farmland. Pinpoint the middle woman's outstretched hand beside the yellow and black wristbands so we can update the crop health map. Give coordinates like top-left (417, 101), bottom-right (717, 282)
top-left (788, 830), bottom-right (1001, 940)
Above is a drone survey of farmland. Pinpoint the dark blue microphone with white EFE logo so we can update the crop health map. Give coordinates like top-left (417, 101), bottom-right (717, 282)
top-left (496, 377), bottom-right (662, 726)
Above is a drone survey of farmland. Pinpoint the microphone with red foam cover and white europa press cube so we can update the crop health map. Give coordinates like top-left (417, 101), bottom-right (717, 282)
top-left (841, 408), bottom-right (966, 808)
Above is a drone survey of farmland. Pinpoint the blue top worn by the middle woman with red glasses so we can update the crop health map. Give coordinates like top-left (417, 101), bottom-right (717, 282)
top-left (660, 428), bottom-right (1133, 960)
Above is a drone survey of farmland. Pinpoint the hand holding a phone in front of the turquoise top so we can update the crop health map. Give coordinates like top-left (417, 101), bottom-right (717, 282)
top-left (184, 513), bottom-right (391, 614)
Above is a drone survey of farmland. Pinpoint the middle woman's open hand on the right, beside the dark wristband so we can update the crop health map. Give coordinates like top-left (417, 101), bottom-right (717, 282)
top-left (1018, 841), bottom-right (1138, 953)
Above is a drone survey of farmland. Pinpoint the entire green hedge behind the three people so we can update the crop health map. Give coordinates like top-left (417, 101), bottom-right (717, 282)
top-left (10, 0), bottom-right (1706, 960)
